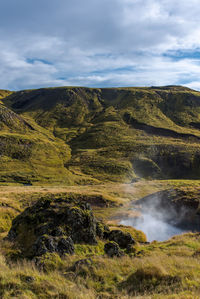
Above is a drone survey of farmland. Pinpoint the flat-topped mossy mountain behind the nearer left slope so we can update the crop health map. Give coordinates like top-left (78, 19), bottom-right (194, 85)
top-left (2, 86), bottom-right (200, 182)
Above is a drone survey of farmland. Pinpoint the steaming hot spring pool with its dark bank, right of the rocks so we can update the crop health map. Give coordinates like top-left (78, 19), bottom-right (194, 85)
top-left (120, 190), bottom-right (200, 242)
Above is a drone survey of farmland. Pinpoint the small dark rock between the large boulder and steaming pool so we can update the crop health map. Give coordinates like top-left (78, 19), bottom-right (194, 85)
top-left (108, 229), bottom-right (135, 248)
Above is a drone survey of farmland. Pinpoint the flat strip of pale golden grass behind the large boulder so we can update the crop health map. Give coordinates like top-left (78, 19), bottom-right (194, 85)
top-left (0, 180), bottom-right (200, 237)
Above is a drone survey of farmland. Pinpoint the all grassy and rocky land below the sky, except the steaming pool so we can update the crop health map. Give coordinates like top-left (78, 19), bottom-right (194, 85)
top-left (0, 86), bottom-right (200, 299)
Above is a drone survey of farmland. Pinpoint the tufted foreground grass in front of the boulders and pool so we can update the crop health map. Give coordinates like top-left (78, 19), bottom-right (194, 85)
top-left (0, 234), bottom-right (200, 298)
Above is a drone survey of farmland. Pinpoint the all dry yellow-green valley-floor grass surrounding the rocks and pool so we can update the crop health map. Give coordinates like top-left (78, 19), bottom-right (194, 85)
top-left (0, 181), bottom-right (200, 299)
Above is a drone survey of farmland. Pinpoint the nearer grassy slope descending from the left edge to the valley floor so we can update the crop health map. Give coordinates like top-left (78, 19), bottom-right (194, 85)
top-left (0, 91), bottom-right (73, 184)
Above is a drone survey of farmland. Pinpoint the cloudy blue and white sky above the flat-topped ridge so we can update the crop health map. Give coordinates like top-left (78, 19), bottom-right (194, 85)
top-left (0, 0), bottom-right (200, 90)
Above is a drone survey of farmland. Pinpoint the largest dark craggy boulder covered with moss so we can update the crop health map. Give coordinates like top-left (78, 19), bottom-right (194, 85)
top-left (7, 198), bottom-right (109, 258)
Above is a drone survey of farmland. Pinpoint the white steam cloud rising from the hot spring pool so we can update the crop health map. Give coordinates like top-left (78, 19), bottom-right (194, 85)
top-left (120, 195), bottom-right (192, 242)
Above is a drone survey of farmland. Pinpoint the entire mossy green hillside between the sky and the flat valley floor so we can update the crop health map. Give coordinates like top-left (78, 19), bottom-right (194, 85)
top-left (0, 86), bottom-right (200, 184)
